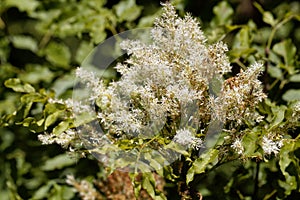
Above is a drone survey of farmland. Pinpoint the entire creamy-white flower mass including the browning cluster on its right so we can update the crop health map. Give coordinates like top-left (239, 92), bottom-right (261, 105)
top-left (72, 4), bottom-right (266, 152)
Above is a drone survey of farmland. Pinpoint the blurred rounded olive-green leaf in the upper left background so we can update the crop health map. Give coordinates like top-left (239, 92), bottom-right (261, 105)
top-left (45, 42), bottom-right (71, 67)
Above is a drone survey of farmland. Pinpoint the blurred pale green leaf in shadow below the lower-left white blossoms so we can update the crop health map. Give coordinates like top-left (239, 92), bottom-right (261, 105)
top-left (41, 154), bottom-right (77, 171)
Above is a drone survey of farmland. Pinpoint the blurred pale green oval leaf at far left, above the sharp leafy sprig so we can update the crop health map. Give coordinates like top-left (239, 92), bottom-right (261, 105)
top-left (11, 35), bottom-right (38, 52)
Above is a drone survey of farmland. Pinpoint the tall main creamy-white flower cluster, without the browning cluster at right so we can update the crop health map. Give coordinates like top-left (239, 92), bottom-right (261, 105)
top-left (76, 4), bottom-right (231, 147)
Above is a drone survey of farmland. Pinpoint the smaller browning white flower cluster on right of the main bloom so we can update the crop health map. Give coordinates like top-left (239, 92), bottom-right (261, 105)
top-left (213, 63), bottom-right (266, 124)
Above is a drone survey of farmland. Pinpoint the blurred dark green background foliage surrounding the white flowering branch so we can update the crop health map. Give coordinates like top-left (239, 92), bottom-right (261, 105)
top-left (0, 0), bottom-right (300, 200)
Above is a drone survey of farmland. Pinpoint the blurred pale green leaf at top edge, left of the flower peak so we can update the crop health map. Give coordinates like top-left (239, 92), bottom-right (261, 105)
top-left (113, 0), bottom-right (142, 22)
